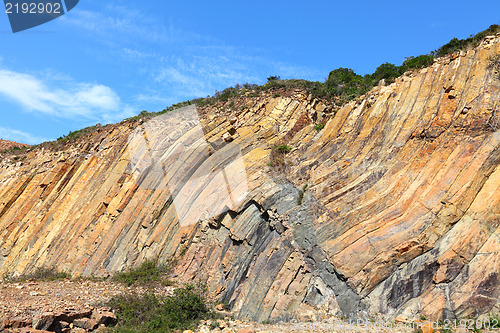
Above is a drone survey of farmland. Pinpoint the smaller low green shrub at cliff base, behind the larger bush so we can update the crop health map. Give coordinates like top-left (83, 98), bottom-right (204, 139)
top-left (113, 260), bottom-right (172, 286)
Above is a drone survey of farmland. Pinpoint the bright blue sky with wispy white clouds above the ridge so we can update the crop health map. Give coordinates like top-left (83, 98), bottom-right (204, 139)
top-left (0, 0), bottom-right (500, 144)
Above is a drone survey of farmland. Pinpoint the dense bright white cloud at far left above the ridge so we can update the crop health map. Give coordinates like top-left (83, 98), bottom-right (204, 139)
top-left (0, 69), bottom-right (132, 122)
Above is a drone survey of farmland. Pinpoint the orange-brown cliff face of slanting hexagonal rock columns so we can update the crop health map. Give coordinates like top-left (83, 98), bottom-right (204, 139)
top-left (0, 36), bottom-right (500, 320)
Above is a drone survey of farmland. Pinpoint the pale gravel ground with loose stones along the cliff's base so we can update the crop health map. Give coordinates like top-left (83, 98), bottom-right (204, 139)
top-left (0, 280), bottom-right (492, 333)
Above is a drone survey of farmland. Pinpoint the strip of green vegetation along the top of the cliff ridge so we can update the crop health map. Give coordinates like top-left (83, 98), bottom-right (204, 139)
top-left (0, 24), bottom-right (500, 155)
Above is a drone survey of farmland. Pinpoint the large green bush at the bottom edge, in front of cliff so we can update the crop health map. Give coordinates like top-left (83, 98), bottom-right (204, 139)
top-left (108, 285), bottom-right (215, 333)
